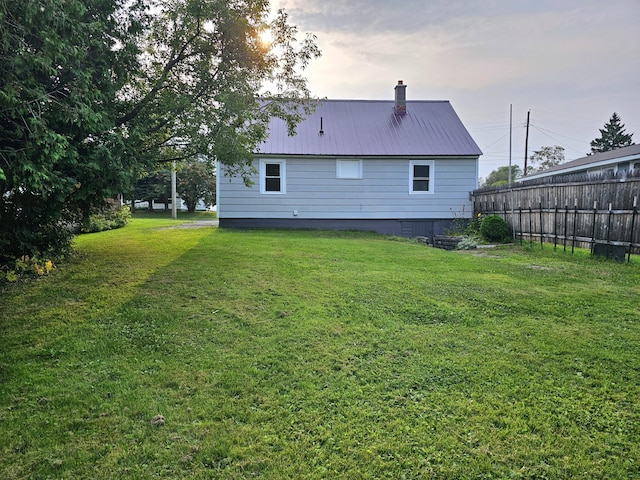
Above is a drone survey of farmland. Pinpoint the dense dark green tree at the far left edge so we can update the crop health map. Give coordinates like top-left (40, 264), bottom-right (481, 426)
top-left (0, 0), bottom-right (143, 263)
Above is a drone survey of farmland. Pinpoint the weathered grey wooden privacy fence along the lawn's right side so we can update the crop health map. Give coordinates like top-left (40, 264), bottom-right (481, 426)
top-left (472, 172), bottom-right (640, 261)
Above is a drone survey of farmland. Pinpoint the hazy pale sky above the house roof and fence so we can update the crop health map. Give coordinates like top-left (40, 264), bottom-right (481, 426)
top-left (272, 0), bottom-right (640, 177)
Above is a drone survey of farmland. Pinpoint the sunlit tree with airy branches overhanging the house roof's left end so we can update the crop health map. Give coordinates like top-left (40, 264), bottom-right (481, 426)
top-left (116, 0), bottom-right (320, 184)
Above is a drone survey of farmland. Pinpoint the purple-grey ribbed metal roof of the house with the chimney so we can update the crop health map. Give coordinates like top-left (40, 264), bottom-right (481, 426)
top-left (258, 100), bottom-right (482, 156)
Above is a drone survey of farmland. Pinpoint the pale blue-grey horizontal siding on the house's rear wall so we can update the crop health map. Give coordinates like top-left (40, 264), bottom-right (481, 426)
top-left (218, 156), bottom-right (477, 220)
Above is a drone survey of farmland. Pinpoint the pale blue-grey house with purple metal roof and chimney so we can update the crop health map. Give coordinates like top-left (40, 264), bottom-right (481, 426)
top-left (217, 82), bottom-right (482, 237)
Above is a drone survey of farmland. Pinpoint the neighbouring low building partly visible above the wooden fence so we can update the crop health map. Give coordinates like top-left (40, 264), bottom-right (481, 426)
top-left (518, 145), bottom-right (640, 181)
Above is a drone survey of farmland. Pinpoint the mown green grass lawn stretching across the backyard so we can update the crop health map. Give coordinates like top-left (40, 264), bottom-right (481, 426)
top-left (0, 218), bottom-right (640, 479)
